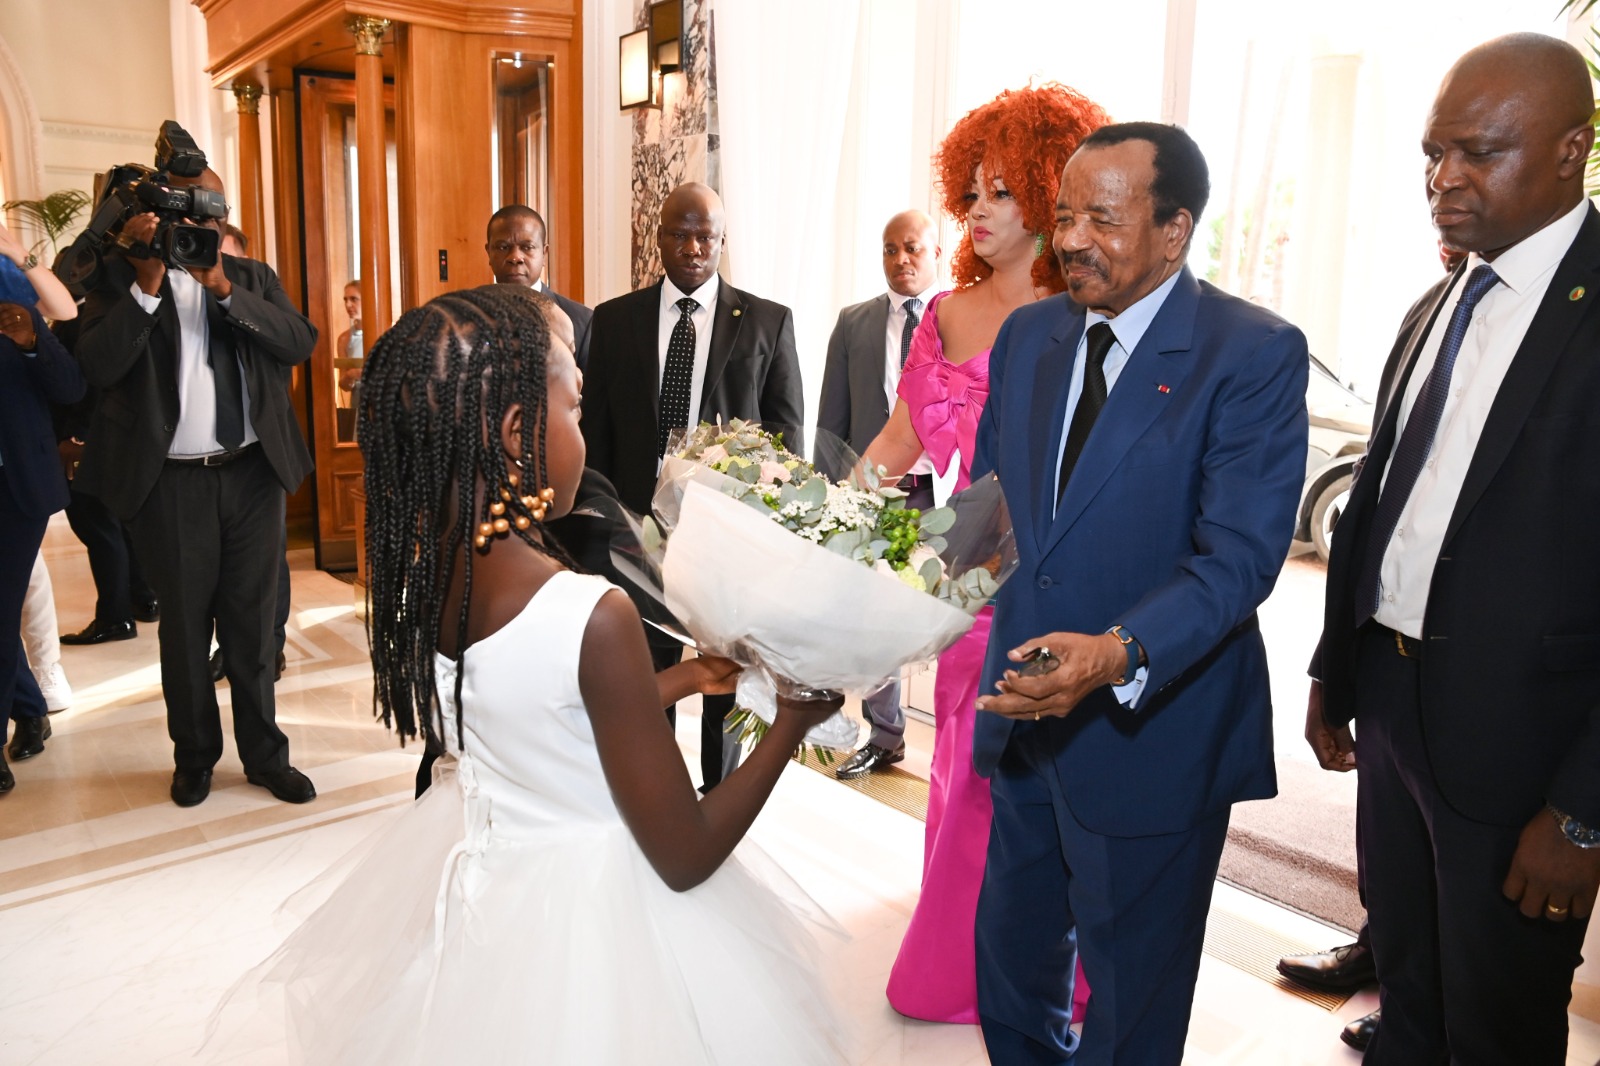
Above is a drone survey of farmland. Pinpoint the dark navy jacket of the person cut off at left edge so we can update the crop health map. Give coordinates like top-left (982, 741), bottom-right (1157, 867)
top-left (0, 307), bottom-right (83, 515)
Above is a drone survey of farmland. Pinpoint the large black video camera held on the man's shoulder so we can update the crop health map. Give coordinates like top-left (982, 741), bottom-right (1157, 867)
top-left (54, 118), bottom-right (227, 296)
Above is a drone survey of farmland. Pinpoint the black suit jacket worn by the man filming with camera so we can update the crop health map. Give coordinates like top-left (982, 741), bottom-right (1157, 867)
top-left (75, 256), bottom-right (317, 520)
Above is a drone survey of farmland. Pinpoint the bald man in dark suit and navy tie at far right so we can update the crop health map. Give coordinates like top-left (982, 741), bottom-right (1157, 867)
top-left (1306, 34), bottom-right (1600, 1066)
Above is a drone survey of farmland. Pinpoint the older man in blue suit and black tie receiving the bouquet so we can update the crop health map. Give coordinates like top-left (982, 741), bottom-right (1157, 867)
top-left (973, 123), bottom-right (1307, 1066)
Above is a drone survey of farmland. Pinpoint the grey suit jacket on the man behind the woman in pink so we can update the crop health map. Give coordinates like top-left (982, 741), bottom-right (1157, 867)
top-left (816, 295), bottom-right (890, 479)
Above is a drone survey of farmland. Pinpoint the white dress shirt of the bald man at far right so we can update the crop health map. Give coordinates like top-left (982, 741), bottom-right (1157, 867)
top-left (1374, 200), bottom-right (1589, 639)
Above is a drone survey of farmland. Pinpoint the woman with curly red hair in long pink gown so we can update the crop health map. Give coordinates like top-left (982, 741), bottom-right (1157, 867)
top-left (866, 83), bottom-right (1110, 1024)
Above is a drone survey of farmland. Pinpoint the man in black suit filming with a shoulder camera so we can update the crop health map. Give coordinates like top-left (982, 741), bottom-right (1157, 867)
top-left (77, 163), bottom-right (317, 807)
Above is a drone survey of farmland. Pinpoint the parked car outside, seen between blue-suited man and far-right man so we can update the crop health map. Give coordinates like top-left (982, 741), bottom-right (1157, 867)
top-left (1294, 355), bottom-right (1373, 562)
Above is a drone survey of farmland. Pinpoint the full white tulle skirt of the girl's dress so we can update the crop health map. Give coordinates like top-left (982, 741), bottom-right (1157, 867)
top-left (202, 775), bottom-right (848, 1066)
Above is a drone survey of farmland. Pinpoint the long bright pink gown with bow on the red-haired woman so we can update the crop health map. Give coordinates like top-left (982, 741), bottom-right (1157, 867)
top-left (888, 293), bottom-right (1090, 1024)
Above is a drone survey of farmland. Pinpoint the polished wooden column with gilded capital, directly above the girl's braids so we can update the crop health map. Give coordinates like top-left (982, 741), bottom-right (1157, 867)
top-left (349, 14), bottom-right (394, 349)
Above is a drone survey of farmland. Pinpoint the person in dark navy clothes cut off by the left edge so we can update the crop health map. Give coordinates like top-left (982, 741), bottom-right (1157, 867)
top-left (0, 299), bottom-right (83, 794)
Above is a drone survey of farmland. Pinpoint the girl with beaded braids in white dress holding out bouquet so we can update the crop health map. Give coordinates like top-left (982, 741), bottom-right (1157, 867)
top-left (212, 290), bottom-right (846, 1066)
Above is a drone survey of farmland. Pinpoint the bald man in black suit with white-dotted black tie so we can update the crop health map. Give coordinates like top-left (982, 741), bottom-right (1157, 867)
top-left (582, 184), bottom-right (805, 787)
